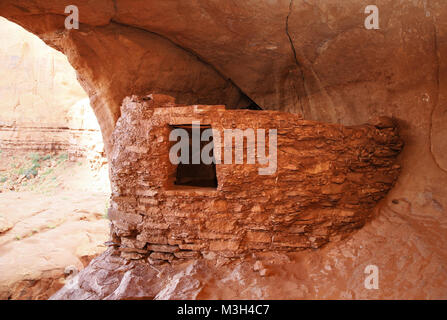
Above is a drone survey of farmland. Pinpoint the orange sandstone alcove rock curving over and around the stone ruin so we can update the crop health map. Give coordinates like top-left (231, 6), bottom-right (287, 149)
top-left (0, 0), bottom-right (447, 298)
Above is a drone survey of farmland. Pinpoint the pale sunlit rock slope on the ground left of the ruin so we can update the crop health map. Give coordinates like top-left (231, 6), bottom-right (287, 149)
top-left (0, 191), bottom-right (109, 299)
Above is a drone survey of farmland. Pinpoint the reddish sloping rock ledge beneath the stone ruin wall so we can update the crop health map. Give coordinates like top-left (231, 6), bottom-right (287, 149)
top-left (52, 192), bottom-right (447, 299)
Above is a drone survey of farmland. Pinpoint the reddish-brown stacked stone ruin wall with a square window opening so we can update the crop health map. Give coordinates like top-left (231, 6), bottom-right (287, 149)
top-left (109, 95), bottom-right (403, 263)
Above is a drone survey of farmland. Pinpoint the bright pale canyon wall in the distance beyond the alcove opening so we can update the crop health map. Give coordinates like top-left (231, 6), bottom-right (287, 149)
top-left (0, 18), bottom-right (104, 162)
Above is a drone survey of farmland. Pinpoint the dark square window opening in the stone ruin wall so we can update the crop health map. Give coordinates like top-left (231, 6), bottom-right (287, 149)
top-left (171, 124), bottom-right (217, 188)
